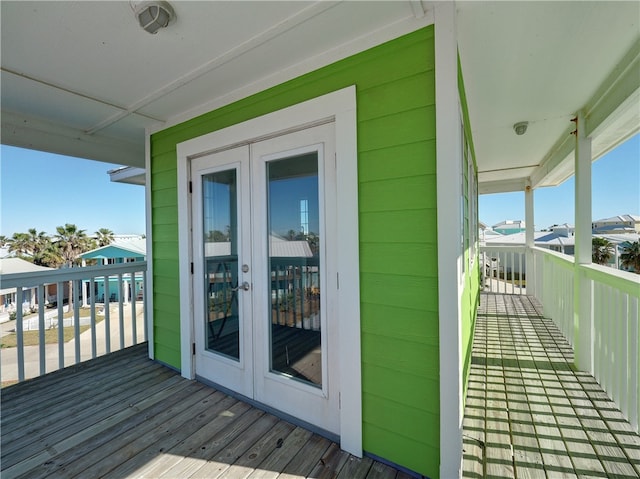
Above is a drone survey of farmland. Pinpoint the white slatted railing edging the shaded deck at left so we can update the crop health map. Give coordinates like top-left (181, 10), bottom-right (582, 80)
top-left (0, 261), bottom-right (147, 383)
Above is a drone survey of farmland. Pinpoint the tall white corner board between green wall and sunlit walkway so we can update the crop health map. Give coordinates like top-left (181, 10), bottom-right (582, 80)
top-left (434, 2), bottom-right (464, 477)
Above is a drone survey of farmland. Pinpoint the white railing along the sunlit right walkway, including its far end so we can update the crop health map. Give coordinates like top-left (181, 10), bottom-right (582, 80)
top-left (480, 246), bottom-right (640, 431)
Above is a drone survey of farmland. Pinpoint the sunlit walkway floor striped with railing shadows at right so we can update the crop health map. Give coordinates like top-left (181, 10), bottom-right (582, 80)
top-left (463, 294), bottom-right (640, 479)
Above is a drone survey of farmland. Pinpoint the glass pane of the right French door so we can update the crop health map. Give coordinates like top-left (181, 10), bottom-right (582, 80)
top-left (267, 152), bottom-right (322, 387)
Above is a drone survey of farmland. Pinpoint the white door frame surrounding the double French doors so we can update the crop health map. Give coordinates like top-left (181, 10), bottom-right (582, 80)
top-left (177, 86), bottom-right (362, 457)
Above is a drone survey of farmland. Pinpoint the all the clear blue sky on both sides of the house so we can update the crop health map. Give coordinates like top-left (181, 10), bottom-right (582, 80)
top-left (0, 135), bottom-right (640, 240)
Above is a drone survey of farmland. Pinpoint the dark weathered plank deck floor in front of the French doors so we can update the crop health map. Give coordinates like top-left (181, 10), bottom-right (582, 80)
top-left (0, 345), bottom-right (409, 479)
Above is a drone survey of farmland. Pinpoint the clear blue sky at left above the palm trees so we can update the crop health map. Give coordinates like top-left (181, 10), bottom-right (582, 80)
top-left (0, 145), bottom-right (145, 237)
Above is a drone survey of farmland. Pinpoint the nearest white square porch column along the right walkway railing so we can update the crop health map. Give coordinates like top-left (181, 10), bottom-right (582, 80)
top-left (573, 112), bottom-right (593, 372)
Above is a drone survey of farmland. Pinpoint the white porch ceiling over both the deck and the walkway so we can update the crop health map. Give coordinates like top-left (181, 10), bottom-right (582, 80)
top-left (0, 0), bottom-right (640, 192)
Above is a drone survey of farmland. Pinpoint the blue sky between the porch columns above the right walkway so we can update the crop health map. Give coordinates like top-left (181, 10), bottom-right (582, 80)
top-left (478, 135), bottom-right (640, 230)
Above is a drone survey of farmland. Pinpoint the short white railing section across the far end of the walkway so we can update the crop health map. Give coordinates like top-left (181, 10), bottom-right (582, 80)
top-left (480, 245), bottom-right (526, 294)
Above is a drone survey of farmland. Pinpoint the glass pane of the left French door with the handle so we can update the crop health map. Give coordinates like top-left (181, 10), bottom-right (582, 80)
top-left (202, 169), bottom-right (240, 360)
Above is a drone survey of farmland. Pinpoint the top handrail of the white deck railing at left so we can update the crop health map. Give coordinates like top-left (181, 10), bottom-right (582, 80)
top-left (0, 261), bottom-right (147, 289)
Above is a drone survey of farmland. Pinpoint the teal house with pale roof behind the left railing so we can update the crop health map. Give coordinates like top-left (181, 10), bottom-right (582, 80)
top-left (80, 236), bottom-right (147, 306)
